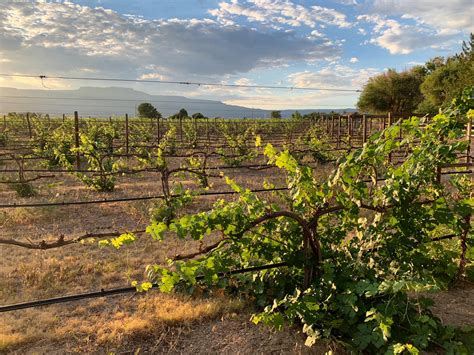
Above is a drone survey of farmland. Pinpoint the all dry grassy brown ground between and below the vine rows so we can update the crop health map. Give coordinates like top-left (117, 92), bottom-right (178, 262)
top-left (0, 154), bottom-right (474, 354)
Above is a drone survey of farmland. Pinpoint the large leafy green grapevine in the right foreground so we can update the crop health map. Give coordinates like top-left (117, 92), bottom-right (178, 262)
top-left (107, 91), bottom-right (473, 353)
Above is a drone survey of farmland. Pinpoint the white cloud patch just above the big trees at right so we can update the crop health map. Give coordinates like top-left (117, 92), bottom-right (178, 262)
top-left (357, 14), bottom-right (457, 54)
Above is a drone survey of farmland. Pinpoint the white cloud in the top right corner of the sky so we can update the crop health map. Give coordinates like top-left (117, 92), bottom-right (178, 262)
top-left (372, 0), bottom-right (474, 34)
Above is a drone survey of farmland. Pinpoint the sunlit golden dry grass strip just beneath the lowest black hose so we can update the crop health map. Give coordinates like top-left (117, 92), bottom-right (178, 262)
top-left (0, 292), bottom-right (244, 351)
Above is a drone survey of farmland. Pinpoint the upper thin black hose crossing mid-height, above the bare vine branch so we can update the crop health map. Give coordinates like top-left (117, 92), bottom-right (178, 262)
top-left (0, 187), bottom-right (288, 208)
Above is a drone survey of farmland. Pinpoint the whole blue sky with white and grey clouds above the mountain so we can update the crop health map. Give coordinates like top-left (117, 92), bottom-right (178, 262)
top-left (0, 0), bottom-right (474, 109)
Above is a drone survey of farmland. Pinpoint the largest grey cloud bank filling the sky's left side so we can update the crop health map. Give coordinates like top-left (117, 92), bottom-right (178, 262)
top-left (0, 3), bottom-right (340, 80)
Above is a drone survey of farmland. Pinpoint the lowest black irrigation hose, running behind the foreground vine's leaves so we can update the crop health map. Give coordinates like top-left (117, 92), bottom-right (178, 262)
top-left (0, 262), bottom-right (287, 313)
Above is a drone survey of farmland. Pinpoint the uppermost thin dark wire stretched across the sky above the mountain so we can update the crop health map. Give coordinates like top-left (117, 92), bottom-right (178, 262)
top-left (0, 73), bottom-right (362, 92)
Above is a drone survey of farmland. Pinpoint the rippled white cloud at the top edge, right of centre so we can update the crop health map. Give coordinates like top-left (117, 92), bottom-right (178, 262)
top-left (209, 0), bottom-right (351, 28)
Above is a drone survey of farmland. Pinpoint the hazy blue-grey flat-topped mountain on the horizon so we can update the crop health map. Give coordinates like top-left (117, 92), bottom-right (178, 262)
top-left (0, 87), bottom-right (355, 118)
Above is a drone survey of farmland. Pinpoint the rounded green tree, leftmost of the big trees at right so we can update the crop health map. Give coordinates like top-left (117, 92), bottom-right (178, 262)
top-left (357, 66), bottom-right (426, 113)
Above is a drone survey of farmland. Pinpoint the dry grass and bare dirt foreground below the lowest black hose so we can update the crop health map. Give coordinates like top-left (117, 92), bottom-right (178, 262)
top-left (0, 291), bottom-right (334, 354)
